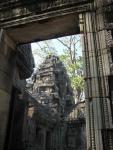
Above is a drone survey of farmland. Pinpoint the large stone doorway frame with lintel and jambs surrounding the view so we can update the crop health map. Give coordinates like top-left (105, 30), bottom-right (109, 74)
top-left (0, 0), bottom-right (113, 150)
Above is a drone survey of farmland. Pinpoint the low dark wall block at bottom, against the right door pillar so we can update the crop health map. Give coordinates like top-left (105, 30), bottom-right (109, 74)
top-left (66, 118), bottom-right (87, 150)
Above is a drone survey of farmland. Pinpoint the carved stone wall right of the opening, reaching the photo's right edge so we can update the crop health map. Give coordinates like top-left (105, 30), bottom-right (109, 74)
top-left (81, 0), bottom-right (113, 150)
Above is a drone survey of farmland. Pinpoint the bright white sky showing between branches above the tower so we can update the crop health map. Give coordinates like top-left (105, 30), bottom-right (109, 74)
top-left (31, 35), bottom-right (82, 67)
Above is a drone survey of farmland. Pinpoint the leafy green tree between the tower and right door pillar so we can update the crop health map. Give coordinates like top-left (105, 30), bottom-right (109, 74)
top-left (57, 35), bottom-right (84, 102)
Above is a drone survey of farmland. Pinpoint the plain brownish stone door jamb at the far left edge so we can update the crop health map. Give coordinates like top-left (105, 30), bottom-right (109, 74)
top-left (0, 30), bottom-right (15, 150)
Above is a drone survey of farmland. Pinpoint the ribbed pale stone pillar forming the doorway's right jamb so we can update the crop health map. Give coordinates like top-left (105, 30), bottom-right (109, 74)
top-left (80, 11), bottom-right (111, 150)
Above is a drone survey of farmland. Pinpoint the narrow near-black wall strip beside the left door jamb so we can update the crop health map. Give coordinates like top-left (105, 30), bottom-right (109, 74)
top-left (5, 87), bottom-right (26, 150)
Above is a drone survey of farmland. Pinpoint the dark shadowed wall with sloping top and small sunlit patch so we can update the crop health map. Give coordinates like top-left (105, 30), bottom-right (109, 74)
top-left (5, 88), bottom-right (57, 150)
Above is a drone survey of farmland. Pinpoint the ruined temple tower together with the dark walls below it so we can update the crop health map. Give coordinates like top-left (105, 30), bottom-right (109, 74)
top-left (6, 53), bottom-right (86, 150)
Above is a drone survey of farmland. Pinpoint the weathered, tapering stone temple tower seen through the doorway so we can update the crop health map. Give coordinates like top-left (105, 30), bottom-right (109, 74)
top-left (33, 55), bottom-right (74, 116)
